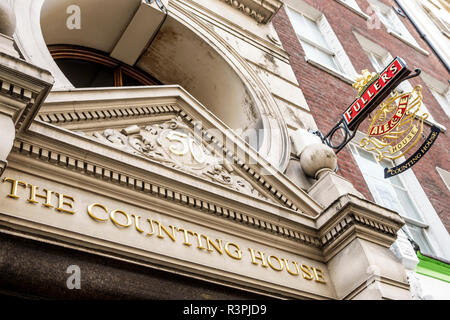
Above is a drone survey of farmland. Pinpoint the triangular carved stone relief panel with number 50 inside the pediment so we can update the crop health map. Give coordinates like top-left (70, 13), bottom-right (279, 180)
top-left (92, 117), bottom-right (268, 200)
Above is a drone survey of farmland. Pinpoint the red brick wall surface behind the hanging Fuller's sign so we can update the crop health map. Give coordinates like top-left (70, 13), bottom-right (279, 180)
top-left (273, 0), bottom-right (450, 230)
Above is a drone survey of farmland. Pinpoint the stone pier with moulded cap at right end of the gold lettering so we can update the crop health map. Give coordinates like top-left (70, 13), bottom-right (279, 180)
top-left (317, 194), bottom-right (411, 300)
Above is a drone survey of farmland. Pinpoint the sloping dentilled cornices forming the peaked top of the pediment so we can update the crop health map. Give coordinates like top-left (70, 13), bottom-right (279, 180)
top-left (38, 86), bottom-right (321, 216)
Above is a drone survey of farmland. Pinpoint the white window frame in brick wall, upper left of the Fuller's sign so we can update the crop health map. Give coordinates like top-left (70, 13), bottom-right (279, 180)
top-left (285, 0), bottom-right (357, 84)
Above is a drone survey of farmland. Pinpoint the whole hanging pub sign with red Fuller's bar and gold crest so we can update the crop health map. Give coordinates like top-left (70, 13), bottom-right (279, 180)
top-left (315, 57), bottom-right (440, 178)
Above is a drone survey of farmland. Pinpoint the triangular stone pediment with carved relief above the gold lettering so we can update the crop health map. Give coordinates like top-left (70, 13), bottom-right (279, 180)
top-left (37, 86), bottom-right (322, 216)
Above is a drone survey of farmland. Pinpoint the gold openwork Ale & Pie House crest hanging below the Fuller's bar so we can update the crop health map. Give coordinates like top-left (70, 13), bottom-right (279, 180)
top-left (360, 86), bottom-right (428, 162)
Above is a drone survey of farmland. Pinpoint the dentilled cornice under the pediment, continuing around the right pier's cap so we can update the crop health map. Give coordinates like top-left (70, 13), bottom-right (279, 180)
top-left (7, 131), bottom-right (404, 261)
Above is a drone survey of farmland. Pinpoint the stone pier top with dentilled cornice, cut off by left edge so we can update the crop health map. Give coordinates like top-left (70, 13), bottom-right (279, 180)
top-left (0, 0), bottom-right (53, 176)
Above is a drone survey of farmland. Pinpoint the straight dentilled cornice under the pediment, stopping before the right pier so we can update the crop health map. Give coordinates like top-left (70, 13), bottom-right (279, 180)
top-left (10, 139), bottom-right (321, 255)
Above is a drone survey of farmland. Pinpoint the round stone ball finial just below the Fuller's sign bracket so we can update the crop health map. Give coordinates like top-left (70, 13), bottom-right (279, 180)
top-left (300, 143), bottom-right (337, 179)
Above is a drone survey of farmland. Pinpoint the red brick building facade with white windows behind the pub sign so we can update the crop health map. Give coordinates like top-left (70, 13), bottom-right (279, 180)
top-left (273, 0), bottom-right (450, 298)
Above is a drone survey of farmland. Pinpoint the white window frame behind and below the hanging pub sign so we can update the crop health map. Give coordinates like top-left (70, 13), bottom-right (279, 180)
top-left (348, 131), bottom-right (450, 260)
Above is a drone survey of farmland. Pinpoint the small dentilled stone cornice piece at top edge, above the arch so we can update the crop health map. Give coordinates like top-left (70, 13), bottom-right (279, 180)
top-left (220, 0), bottom-right (283, 24)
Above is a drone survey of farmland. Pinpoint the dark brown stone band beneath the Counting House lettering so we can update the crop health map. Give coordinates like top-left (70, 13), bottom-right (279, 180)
top-left (0, 233), bottom-right (267, 300)
